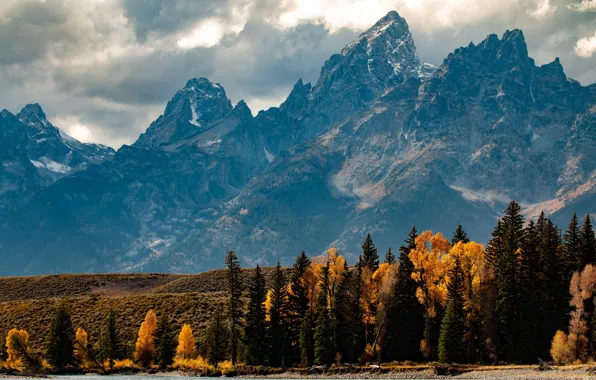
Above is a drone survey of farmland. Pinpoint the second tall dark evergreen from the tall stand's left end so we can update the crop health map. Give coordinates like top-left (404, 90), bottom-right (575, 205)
top-left (244, 265), bottom-right (268, 365)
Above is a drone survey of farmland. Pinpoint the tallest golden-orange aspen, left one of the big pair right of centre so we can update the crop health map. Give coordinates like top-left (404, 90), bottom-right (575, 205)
top-left (409, 231), bottom-right (451, 359)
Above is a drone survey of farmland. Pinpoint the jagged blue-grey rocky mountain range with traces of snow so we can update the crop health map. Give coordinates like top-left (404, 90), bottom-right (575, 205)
top-left (0, 12), bottom-right (596, 274)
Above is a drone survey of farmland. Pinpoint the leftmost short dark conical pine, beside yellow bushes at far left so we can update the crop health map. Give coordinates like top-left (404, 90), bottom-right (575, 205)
top-left (46, 303), bottom-right (75, 369)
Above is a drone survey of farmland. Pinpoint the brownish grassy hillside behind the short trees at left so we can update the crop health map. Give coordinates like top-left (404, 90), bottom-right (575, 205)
top-left (0, 268), bottom-right (289, 351)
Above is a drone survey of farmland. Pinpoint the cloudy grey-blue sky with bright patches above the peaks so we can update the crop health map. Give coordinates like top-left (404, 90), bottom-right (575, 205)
top-left (0, 0), bottom-right (596, 148)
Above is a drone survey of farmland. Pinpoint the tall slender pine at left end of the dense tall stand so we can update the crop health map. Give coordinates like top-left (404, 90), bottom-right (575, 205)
top-left (226, 251), bottom-right (243, 365)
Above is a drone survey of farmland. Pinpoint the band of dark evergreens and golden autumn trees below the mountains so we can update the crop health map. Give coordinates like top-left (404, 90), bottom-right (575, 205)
top-left (1, 202), bottom-right (596, 373)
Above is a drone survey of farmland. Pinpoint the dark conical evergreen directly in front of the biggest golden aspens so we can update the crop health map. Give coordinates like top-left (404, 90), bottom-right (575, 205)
top-left (439, 259), bottom-right (466, 363)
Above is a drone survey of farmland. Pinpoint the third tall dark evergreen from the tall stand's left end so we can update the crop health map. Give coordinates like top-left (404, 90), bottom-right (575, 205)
top-left (268, 262), bottom-right (288, 367)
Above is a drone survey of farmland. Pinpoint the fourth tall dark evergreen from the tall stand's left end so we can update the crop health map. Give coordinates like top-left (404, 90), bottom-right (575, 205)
top-left (286, 251), bottom-right (312, 364)
